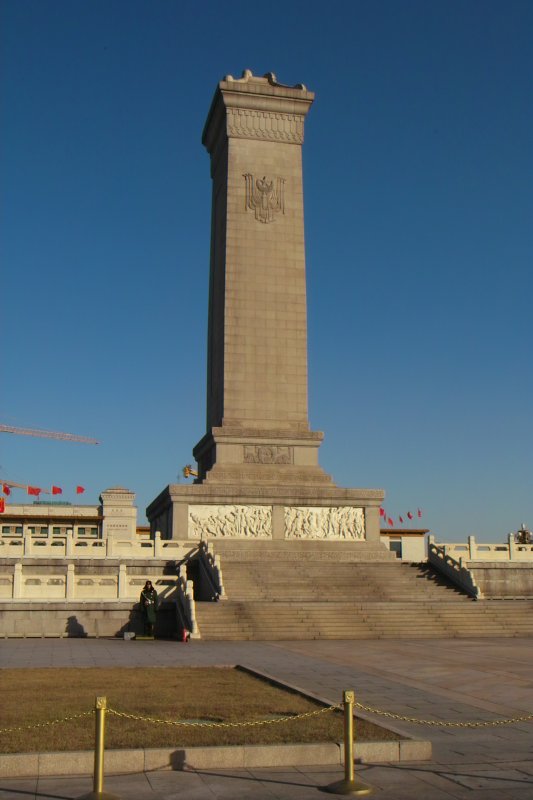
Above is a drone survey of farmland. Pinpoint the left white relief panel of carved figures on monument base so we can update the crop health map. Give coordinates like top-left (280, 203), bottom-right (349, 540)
top-left (189, 505), bottom-right (272, 539)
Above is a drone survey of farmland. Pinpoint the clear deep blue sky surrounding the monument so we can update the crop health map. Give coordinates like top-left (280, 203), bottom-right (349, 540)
top-left (0, 0), bottom-right (533, 541)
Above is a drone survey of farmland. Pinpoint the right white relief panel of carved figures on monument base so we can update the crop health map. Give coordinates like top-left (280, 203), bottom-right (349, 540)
top-left (285, 506), bottom-right (365, 540)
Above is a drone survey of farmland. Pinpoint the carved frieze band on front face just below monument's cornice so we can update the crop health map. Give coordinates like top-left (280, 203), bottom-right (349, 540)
top-left (227, 108), bottom-right (304, 144)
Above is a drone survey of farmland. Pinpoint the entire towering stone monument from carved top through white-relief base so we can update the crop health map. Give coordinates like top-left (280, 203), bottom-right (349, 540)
top-left (147, 70), bottom-right (384, 541)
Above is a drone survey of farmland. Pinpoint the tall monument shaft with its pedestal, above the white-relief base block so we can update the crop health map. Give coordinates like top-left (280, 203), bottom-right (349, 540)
top-left (195, 71), bottom-right (330, 483)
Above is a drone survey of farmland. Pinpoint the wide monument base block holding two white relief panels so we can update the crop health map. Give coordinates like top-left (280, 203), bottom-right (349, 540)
top-left (146, 483), bottom-right (384, 541)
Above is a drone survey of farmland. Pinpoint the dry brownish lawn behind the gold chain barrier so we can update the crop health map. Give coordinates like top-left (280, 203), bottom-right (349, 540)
top-left (0, 667), bottom-right (398, 753)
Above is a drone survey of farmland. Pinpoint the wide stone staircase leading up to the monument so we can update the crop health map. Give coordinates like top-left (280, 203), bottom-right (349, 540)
top-left (196, 540), bottom-right (533, 641)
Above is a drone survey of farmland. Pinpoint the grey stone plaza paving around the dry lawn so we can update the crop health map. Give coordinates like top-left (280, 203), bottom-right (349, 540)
top-left (0, 639), bottom-right (533, 800)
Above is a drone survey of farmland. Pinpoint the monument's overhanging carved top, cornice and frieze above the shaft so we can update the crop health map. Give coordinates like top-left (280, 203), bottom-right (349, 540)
top-left (202, 69), bottom-right (315, 153)
